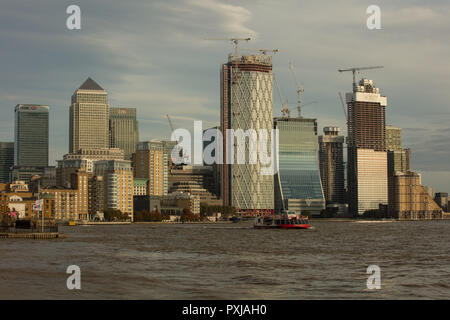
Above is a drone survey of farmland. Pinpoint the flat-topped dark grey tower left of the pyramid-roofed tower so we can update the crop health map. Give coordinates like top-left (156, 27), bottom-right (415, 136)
top-left (14, 104), bottom-right (49, 167)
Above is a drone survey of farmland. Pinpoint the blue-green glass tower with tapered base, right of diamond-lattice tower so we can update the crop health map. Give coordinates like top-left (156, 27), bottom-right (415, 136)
top-left (274, 117), bottom-right (325, 215)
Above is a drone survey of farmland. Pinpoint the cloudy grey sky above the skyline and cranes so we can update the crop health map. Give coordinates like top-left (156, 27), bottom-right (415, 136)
top-left (0, 0), bottom-right (450, 191)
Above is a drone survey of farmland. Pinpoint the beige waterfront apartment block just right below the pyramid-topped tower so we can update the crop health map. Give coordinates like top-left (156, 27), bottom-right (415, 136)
top-left (94, 160), bottom-right (134, 221)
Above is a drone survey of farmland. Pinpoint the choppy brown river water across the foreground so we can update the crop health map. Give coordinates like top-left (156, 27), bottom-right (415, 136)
top-left (0, 220), bottom-right (450, 299)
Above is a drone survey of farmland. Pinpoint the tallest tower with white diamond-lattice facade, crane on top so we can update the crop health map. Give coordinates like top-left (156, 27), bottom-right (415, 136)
top-left (220, 55), bottom-right (274, 211)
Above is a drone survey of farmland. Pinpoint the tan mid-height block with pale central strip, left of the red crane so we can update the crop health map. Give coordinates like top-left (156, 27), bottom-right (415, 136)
top-left (133, 141), bottom-right (169, 196)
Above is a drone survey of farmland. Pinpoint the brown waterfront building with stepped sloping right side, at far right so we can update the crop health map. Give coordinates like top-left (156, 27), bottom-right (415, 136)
top-left (388, 171), bottom-right (443, 220)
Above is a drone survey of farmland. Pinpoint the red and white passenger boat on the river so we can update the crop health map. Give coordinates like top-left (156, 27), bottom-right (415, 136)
top-left (253, 213), bottom-right (311, 229)
